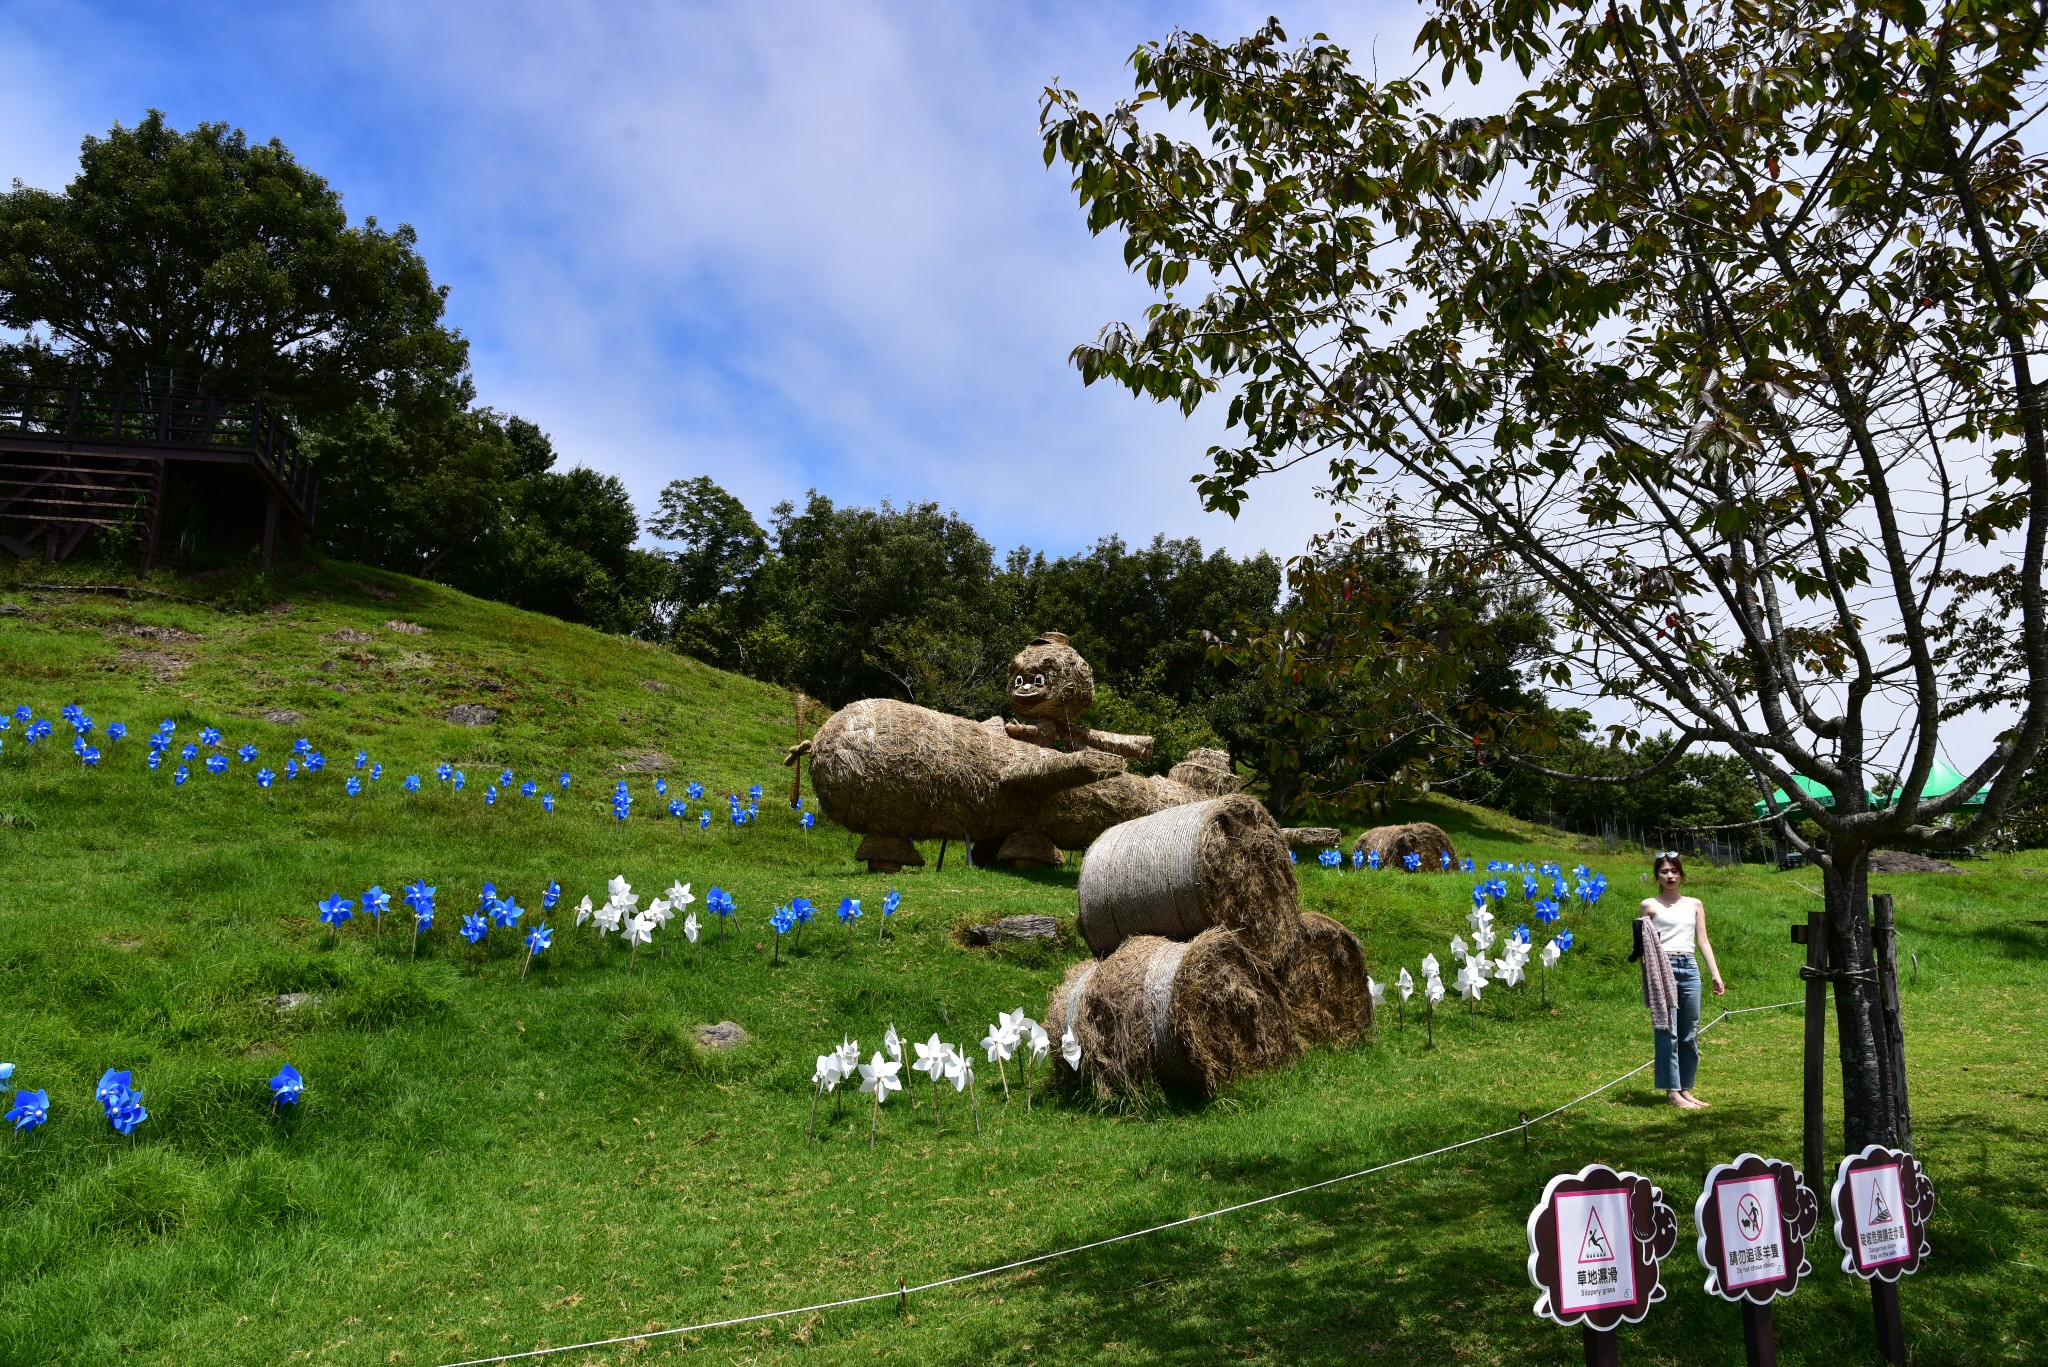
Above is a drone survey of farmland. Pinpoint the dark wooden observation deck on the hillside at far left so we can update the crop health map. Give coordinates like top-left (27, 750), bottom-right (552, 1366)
top-left (0, 381), bottom-right (319, 572)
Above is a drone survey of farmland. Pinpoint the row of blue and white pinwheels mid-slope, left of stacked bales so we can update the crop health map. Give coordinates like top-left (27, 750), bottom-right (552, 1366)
top-left (315, 875), bottom-right (903, 978)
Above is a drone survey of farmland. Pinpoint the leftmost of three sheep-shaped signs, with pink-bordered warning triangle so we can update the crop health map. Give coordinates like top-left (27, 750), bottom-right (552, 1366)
top-left (1528, 1162), bottom-right (1677, 1367)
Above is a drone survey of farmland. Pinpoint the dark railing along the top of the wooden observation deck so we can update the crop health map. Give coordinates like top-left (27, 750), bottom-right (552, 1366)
top-left (0, 379), bottom-right (319, 525)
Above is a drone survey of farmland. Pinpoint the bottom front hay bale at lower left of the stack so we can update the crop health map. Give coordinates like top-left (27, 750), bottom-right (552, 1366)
top-left (1047, 928), bottom-right (1300, 1096)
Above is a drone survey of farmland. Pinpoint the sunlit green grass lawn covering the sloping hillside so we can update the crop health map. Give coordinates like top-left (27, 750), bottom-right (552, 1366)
top-left (0, 568), bottom-right (2048, 1367)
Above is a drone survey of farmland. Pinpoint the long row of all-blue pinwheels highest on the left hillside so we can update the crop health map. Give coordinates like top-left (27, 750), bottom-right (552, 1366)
top-left (0, 703), bottom-right (817, 830)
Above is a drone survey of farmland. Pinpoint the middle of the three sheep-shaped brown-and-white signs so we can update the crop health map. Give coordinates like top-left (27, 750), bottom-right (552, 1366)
top-left (1692, 1154), bottom-right (1821, 1367)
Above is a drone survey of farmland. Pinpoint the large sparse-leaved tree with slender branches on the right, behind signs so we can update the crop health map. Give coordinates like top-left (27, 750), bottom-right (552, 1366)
top-left (1042, 0), bottom-right (2048, 1148)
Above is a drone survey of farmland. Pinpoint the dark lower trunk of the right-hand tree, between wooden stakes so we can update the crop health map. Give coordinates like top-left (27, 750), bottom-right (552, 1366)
top-left (1808, 856), bottom-right (1901, 1155)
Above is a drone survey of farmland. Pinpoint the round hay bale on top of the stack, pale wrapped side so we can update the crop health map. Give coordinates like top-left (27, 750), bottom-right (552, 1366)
top-left (1077, 795), bottom-right (1300, 969)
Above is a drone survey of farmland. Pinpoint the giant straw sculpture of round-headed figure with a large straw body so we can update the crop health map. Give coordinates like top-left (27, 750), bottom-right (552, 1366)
top-left (791, 631), bottom-right (1335, 873)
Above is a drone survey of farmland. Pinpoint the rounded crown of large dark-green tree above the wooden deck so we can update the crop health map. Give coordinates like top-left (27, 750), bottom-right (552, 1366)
top-left (0, 111), bottom-right (467, 416)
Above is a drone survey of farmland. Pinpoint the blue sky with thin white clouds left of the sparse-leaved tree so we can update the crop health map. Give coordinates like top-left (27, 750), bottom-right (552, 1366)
top-left (0, 0), bottom-right (1417, 553)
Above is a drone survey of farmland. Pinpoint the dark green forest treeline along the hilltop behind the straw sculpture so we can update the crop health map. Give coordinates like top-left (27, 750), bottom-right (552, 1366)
top-left (0, 113), bottom-right (1785, 826)
